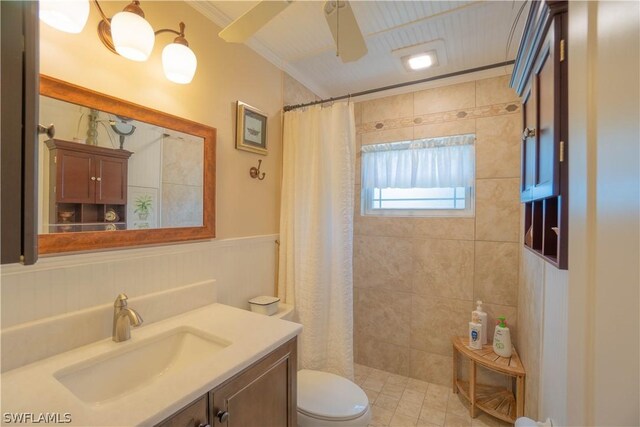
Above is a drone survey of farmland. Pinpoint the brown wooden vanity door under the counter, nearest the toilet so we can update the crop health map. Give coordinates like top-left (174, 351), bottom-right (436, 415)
top-left (211, 339), bottom-right (297, 427)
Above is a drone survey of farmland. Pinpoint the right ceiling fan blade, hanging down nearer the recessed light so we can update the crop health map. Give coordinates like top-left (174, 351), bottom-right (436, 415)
top-left (324, 0), bottom-right (367, 62)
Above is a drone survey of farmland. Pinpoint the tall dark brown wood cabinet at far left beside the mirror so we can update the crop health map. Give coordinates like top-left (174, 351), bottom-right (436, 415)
top-left (0, 1), bottom-right (40, 264)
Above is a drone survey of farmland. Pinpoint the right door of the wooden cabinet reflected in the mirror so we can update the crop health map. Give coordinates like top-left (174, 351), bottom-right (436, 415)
top-left (95, 156), bottom-right (127, 205)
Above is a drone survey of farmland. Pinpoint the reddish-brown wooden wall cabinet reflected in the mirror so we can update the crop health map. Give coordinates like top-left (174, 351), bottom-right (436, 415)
top-left (46, 139), bottom-right (133, 232)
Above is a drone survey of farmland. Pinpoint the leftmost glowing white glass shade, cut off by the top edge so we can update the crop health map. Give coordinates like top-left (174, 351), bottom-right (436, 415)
top-left (39, 0), bottom-right (89, 34)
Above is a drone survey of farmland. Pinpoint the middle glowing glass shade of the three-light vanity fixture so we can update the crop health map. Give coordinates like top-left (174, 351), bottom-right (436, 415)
top-left (111, 12), bottom-right (156, 61)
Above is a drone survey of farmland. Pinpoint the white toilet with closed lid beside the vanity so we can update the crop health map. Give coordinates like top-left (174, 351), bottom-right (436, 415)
top-left (272, 304), bottom-right (371, 427)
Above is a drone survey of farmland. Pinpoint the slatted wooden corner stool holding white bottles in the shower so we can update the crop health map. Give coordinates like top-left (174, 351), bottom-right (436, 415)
top-left (451, 337), bottom-right (526, 423)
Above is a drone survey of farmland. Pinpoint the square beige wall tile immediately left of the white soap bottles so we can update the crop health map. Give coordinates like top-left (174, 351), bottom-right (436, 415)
top-left (411, 295), bottom-right (473, 356)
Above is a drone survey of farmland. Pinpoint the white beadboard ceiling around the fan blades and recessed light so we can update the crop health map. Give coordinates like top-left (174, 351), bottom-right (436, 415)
top-left (190, 0), bottom-right (529, 97)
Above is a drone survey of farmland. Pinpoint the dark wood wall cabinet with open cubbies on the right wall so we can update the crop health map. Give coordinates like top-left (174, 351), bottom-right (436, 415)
top-left (511, 1), bottom-right (569, 270)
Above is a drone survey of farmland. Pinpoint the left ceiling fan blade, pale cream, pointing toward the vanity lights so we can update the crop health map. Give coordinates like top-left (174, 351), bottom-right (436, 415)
top-left (218, 0), bottom-right (291, 43)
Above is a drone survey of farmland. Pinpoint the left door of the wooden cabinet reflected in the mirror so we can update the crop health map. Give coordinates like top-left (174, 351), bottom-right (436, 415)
top-left (54, 150), bottom-right (96, 203)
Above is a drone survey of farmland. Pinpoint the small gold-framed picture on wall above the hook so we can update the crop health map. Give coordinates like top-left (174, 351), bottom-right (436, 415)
top-left (236, 101), bottom-right (267, 156)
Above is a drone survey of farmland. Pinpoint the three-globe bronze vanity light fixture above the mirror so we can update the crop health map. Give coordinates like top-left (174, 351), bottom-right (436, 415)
top-left (40, 0), bottom-right (198, 84)
